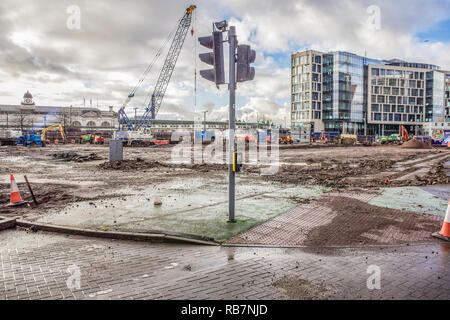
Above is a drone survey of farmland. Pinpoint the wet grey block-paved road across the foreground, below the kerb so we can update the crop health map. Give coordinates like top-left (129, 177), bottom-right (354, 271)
top-left (0, 229), bottom-right (450, 300)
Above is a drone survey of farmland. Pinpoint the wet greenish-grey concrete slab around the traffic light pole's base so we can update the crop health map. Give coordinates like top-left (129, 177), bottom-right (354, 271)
top-left (34, 178), bottom-right (326, 241)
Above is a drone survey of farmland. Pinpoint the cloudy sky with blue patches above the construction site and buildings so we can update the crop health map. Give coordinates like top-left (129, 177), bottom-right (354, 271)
top-left (0, 0), bottom-right (450, 123)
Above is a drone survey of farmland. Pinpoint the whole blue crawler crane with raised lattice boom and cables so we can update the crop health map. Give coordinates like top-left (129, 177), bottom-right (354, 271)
top-left (114, 5), bottom-right (196, 145)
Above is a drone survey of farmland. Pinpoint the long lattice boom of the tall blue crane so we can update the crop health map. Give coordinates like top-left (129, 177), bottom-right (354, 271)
top-left (118, 5), bottom-right (196, 131)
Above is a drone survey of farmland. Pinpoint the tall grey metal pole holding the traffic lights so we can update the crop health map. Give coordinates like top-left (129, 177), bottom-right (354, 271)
top-left (228, 26), bottom-right (236, 222)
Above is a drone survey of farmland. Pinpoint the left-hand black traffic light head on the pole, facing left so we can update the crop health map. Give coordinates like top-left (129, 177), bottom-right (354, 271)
top-left (198, 31), bottom-right (225, 86)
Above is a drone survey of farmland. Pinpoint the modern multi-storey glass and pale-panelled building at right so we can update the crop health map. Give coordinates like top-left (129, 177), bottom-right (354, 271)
top-left (291, 50), bottom-right (450, 135)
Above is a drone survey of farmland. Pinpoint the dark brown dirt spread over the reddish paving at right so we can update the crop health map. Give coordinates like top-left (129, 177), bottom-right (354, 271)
top-left (305, 197), bottom-right (443, 246)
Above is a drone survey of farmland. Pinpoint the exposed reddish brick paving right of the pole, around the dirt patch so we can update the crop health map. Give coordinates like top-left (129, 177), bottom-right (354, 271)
top-left (227, 190), bottom-right (443, 247)
